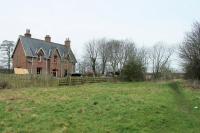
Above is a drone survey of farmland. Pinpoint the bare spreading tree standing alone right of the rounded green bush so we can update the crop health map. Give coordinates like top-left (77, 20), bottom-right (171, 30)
top-left (150, 43), bottom-right (173, 79)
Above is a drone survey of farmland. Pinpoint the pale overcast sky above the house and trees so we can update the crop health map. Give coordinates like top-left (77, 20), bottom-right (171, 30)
top-left (0, 0), bottom-right (200, 58)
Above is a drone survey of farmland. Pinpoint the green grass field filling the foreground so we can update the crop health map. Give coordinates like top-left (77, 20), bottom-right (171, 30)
top-left (0, 82), bottom-right (200, 133)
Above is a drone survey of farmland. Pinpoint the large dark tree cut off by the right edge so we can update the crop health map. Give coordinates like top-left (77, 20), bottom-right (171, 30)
top-left (180, 22), bottom-right (200, 80)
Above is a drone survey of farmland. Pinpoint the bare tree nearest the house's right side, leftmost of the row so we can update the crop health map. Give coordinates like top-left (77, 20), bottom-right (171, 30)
top-left (85, 40), bottom-right (98, 76)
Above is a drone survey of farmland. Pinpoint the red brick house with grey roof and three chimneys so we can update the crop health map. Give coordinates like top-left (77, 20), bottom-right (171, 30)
top-left (12, 30), bottom-right (77, 77)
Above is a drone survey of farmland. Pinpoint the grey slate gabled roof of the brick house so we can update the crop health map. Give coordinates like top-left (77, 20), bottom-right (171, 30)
top-left (13, 36), bottom-right (77, 63)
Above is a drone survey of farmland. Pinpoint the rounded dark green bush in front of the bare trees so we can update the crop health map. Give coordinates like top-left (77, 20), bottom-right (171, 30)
top-left (121, 59), bottom-right (145, 81)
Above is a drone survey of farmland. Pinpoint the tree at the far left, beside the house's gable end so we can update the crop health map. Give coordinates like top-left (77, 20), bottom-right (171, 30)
top-left (0, 40), bottom-right (15, 69)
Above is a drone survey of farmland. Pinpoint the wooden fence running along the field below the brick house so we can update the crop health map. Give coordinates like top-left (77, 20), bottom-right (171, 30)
top-left (0, 73), bottom-right (114, 88)
